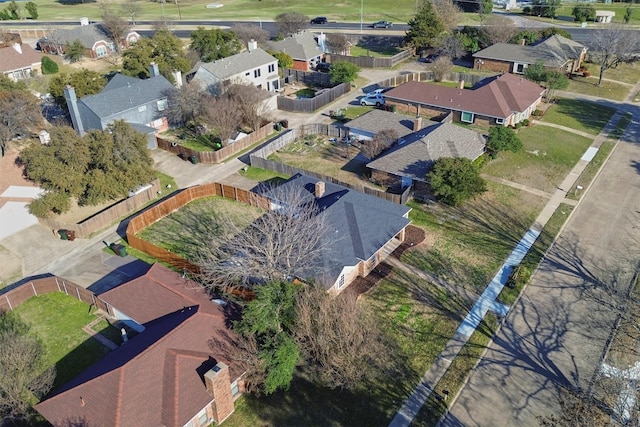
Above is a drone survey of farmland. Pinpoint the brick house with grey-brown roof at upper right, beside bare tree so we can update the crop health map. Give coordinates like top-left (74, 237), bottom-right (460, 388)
top-left (473, 34), bottom-right (587, 74)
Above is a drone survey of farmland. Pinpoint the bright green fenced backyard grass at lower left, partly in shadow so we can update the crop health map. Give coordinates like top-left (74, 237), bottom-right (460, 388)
top-left (14, 292), bottom-right (109, 389)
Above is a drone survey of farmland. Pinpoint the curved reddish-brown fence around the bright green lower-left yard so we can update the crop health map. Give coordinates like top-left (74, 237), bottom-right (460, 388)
top-left (0, 276), bottom-right (108, 313)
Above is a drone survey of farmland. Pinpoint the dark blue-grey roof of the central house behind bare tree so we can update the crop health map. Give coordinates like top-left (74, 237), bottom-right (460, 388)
top-left (270, 174), bottom-right (411, 285)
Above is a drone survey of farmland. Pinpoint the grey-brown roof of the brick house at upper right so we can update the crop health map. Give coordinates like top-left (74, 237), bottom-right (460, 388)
top-left (473, 34), bottom-right (585, 68)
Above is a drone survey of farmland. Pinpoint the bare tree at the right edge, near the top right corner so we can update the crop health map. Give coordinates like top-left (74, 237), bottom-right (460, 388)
top-left (591, 25), bottom-right (640, 86)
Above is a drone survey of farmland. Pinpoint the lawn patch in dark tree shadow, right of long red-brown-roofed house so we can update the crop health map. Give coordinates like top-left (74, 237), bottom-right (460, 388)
top-left (536, 98), bottom-right (615, 135)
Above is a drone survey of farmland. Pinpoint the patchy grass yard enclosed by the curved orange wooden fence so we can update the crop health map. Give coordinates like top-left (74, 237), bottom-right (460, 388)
top-left (138, 196), bottom-right (261, 260)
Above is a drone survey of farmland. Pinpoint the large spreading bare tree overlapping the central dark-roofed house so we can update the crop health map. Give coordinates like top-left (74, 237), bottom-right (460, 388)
top-left (198, 185), bottom-right (329, 292)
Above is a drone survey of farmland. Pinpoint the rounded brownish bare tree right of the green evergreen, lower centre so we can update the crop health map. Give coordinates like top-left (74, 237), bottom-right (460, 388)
top-left (294, 285), bottom-right (391, 389)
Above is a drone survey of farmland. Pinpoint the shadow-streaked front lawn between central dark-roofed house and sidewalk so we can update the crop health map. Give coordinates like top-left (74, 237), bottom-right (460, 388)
top-left (402, 182), bottom-right (547, 293)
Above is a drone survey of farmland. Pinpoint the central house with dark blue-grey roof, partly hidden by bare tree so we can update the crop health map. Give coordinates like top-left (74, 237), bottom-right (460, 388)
top-left (264, 174), bottom-right (411, 293)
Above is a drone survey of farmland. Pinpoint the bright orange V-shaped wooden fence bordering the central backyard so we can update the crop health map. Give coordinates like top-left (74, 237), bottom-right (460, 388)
top-left (127, 182), bottom-right (271, 274)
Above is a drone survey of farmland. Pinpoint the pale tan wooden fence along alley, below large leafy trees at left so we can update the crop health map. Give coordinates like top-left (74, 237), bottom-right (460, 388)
top-left (43, 179), bottom-right (161, 238)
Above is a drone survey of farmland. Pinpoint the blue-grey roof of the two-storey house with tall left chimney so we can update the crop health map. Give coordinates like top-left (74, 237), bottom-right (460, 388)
top-left (79, 74), bottom-right (173, 119)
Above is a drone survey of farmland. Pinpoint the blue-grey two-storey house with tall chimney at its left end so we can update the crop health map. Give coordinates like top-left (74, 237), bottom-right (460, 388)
top-left (64, 63), bottom-right (173, 149)
